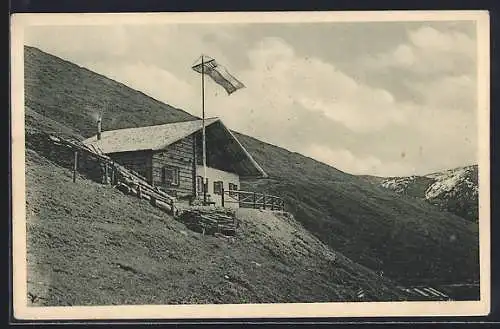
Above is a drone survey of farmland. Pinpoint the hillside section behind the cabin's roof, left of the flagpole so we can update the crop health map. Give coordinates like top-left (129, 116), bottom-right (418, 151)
top-left (25, 47), bottom-right (193, 136)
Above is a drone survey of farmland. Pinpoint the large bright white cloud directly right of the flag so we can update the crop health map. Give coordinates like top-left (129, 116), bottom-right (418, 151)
top-left (209, 38), bottom-right (405, 133)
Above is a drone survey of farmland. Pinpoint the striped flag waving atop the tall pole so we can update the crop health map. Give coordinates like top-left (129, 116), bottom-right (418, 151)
top-left (192, 55), bottom-right (245, 95)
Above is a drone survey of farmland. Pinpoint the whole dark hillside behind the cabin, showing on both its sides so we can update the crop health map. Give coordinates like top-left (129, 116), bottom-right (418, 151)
top-left (25, 48), bottom-right (479, 282)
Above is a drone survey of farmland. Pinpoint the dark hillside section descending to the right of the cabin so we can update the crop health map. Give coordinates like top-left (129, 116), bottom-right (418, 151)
top-left (235, 135), bottom-right (478, 283)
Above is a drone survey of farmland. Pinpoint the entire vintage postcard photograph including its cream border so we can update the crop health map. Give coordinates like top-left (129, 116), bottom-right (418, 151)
top-left (11, 11), bottom-right (490, 319)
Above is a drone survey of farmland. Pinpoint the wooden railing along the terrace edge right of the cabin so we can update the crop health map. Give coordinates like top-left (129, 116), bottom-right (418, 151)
top-left (221, 188), bottom-right (285, 211)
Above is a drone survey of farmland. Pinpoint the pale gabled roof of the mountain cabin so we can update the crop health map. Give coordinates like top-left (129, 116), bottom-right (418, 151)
top-left (83, 118), bottom-right (267, 177)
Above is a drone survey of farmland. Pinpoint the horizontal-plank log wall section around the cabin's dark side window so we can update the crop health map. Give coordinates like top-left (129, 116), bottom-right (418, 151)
top-left (152, 135), bottom-right (194, 197)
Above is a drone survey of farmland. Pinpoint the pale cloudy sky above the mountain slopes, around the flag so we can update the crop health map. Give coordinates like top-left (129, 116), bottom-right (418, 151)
top-left (25, 21), bottom-right (478, 176)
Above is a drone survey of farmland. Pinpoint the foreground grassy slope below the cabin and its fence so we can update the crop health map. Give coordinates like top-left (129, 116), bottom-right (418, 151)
top-left (26, 149), bottom-right (401, 305)
